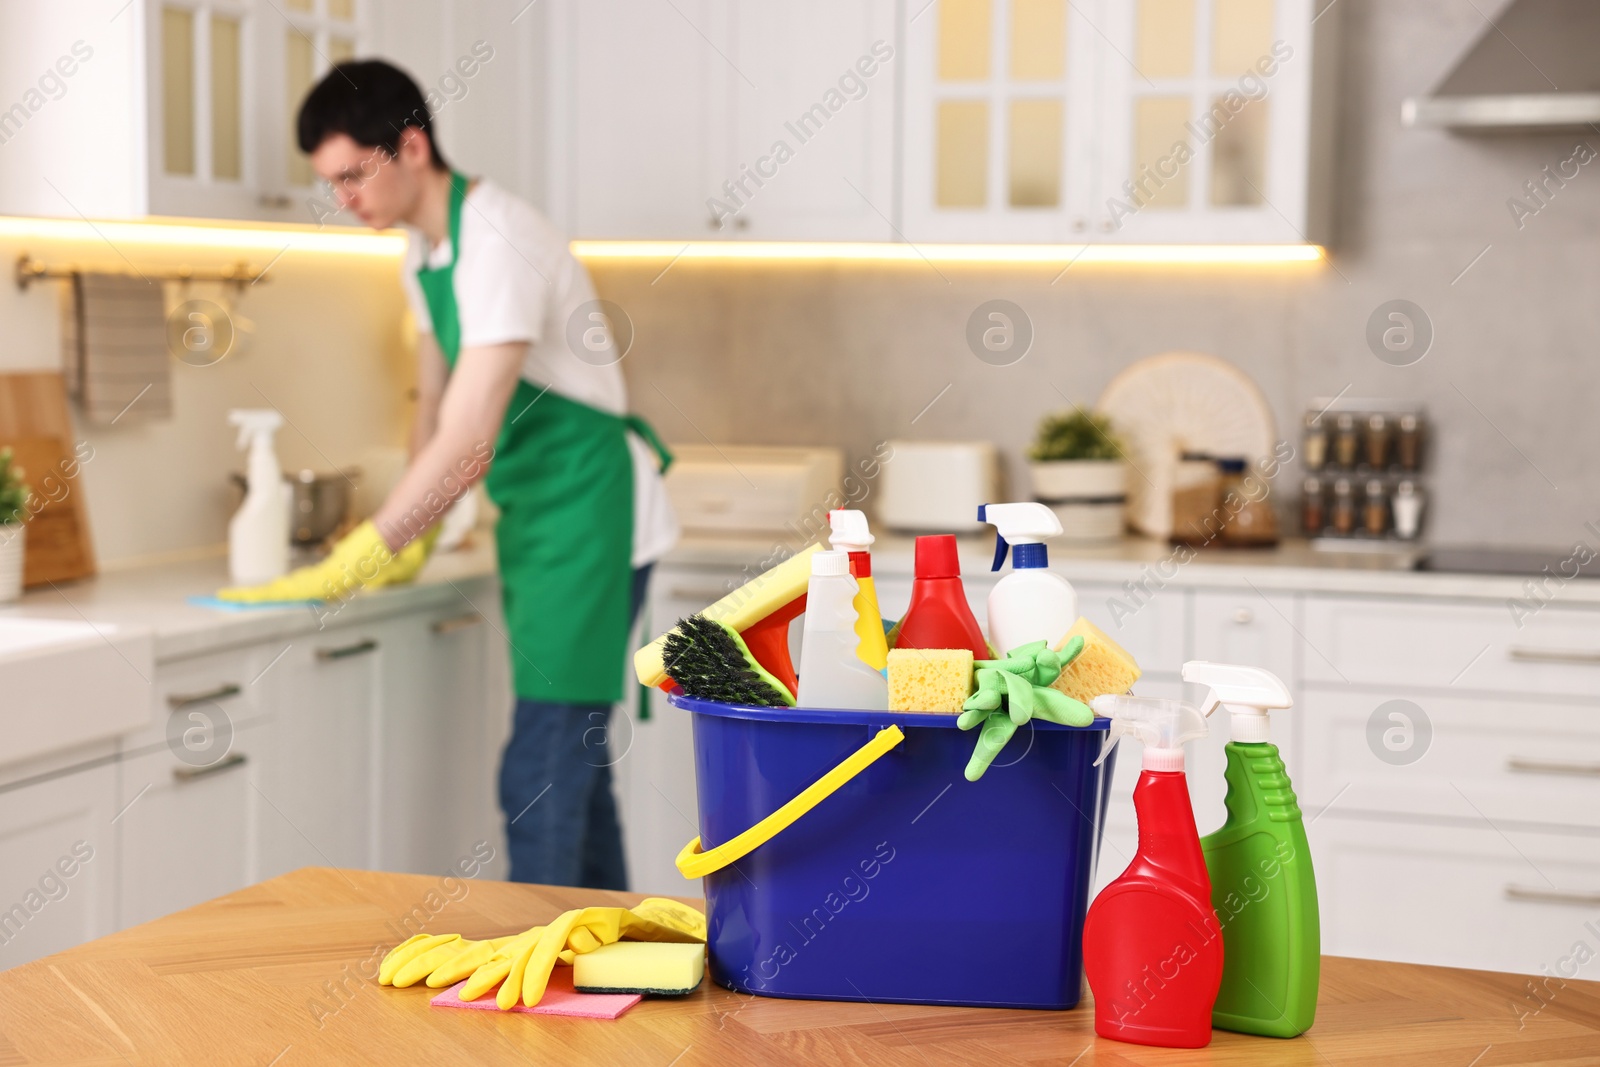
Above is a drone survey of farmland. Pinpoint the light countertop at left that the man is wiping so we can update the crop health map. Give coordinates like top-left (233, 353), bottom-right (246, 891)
top-left (0, 531), bottom-right (498, 661)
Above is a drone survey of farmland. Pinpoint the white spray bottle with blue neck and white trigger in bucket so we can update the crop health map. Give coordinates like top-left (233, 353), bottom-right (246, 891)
top-left (978, 502), bottom-right (1078, 656)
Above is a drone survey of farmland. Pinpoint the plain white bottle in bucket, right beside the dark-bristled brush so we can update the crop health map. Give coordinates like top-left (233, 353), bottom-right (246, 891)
top-left (797, 552), bottom-right (890, 712)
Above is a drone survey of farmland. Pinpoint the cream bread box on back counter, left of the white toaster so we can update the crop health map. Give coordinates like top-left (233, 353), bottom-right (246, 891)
top-left (666, 445), bottom-right (848, 536)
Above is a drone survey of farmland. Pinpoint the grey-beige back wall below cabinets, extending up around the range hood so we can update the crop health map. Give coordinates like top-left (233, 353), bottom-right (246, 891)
top-left (592, 0), bottom-right (1600, 545)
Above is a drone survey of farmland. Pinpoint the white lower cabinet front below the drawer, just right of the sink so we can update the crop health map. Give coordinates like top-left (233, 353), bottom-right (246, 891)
top-left (117, 720), bottom-right (265, 926)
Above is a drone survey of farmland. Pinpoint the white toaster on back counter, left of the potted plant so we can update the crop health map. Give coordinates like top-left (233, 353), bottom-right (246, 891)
top-left (877, 442), bottom-right (1005, 534)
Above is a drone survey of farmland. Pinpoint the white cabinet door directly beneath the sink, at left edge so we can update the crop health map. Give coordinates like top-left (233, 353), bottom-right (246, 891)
top-left (0, 761), bottom-right (118, 968)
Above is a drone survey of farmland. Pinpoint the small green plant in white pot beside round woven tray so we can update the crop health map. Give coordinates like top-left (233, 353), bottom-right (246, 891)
top-left (1027, 406), bottom-right (1128, 541)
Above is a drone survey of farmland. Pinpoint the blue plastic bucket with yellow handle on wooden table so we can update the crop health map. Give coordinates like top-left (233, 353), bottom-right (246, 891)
top-left (669, 693), bottom-right (1114, 1008)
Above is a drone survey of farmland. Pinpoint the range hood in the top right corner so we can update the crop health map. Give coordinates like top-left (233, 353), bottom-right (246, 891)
top-left (1400, 0), bottom-right (1600, 133)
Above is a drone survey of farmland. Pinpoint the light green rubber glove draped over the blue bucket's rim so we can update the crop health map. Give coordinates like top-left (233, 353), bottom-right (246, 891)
top-left (955, 637), bottom-right (1094, 782)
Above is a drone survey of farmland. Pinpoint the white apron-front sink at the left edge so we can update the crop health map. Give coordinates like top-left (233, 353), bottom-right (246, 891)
top-left (0, 616), bottom-right (155, 765)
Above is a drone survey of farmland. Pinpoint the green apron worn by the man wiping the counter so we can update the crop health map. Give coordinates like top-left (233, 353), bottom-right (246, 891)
top-left (416, 174), bottom-right (672, 704)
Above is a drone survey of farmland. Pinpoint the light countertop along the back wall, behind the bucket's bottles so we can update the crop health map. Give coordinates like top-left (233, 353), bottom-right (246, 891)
top-left (664, 534), bottom-right (1600, 606)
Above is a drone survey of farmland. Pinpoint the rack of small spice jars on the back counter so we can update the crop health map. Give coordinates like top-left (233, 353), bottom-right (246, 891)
top-left (1299, 397), bottom-right (1429, 550)
